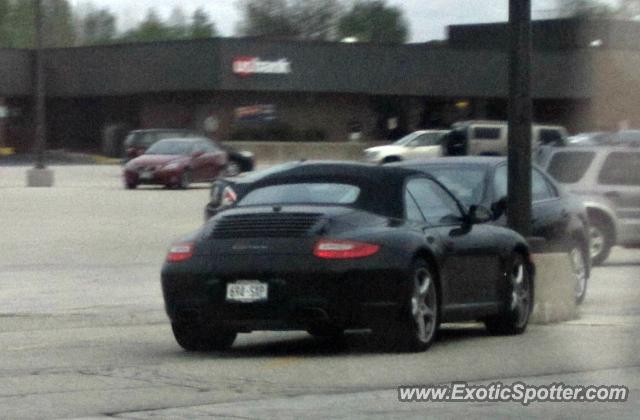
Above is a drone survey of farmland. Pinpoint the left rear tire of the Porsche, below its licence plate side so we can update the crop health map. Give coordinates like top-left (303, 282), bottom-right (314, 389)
top-left (171, 323), bottom-right (238, 351)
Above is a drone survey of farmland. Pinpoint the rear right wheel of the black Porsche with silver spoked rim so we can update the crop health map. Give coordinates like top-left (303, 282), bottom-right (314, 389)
top-left (385, 259), bottom-right (440, 352)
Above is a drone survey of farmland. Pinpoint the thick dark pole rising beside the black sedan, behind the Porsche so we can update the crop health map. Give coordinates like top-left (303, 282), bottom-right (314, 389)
top-left (507, 0), bottom-right (532, 237)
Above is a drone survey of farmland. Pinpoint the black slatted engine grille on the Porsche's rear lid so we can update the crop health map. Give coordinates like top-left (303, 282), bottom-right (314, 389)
top-left (211, 213), bottom-right (321, 239)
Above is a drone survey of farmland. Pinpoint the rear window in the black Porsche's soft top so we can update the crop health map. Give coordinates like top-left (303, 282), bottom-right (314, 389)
top-left (238, 183), bottom-right (360, 206)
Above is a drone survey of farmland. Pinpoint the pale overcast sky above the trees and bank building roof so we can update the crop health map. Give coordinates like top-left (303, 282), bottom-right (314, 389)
top-left (76, 0), bottom-right (613, 42)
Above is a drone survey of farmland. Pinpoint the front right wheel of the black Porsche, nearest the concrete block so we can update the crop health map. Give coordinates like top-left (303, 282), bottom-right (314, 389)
top-left (484, 253), bottom-right (533, 335)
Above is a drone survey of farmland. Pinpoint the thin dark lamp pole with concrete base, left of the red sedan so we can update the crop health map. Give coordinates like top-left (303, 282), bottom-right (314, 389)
top-left (27, 0), bottom-right (53, 187)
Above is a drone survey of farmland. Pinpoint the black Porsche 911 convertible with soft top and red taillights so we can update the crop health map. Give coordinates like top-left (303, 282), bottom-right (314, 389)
top-left (162, 162), bottom-right (534, 351)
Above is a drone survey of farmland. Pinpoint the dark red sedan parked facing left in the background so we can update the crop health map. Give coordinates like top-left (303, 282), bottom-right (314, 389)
top-left (124, 137), bottom-right (228, 189)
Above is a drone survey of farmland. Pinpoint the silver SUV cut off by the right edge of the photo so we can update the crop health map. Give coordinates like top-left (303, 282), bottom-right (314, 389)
top-left (541, 146), bottom-right (640, 264)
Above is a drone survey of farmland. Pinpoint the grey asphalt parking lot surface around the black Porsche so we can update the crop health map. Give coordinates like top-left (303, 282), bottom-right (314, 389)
top-left (0, 165), bottom-right (640, 418)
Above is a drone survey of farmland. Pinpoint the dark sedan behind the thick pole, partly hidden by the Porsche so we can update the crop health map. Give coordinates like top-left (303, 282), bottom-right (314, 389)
top-left (398, 156), bottom-right (590, 303)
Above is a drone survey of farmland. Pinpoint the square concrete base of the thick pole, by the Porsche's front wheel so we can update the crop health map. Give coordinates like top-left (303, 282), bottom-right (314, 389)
top-left (529, 253), bottom-right (578, 324)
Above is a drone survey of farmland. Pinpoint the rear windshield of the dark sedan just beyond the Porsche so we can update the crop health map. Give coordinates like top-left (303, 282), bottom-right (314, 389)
top-left (428, 166), bottom-right (486, 207)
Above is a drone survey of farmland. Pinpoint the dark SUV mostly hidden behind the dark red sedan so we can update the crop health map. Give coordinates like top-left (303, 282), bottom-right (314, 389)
top-left (124, 128), bottom-right (255, 176)
